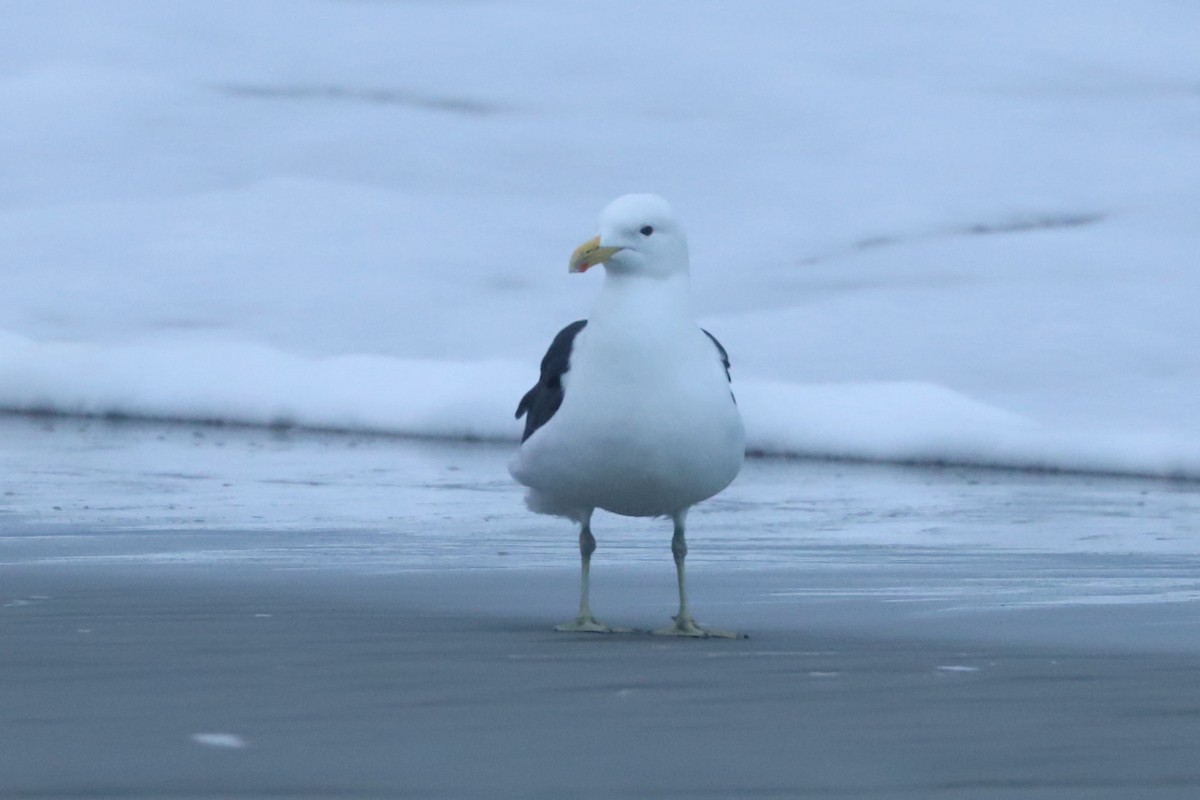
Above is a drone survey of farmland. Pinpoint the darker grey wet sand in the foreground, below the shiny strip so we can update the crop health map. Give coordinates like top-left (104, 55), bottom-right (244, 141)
top-left (0, 564), bottom-right (1200, 800)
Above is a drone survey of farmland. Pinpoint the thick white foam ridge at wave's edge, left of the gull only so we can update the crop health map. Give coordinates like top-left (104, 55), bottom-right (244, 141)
top-left (0, 336), bottom-right (532, 439)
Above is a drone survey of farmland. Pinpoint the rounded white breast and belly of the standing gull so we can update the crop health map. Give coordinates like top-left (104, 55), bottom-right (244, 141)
top-left (510, 329), bottom-right (745, 517)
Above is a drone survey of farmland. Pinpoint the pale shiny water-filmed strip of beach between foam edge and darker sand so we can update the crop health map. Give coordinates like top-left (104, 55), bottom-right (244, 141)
top-left (0, 416), bottom-right (1200, 616)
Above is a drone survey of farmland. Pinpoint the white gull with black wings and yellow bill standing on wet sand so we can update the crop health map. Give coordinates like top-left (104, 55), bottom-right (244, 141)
top-left (509, 194), bottom-right (745, 637)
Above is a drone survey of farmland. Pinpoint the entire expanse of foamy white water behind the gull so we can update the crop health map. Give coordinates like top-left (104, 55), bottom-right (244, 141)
top-left (0, 0), bottom-right (1200, 476)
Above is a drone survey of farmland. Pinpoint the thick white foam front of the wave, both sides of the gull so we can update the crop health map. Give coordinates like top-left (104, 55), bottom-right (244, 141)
top-left (0, 335), bottom-right (1200, 477)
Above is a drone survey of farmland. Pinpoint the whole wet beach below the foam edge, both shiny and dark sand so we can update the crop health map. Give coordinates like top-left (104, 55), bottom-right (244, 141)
top-left (0, 417), bottom-right (1200, 800)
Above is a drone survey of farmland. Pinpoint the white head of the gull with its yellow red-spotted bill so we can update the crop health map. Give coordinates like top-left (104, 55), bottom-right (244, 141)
top-left (570, 194), bottom-right (688, 278)
